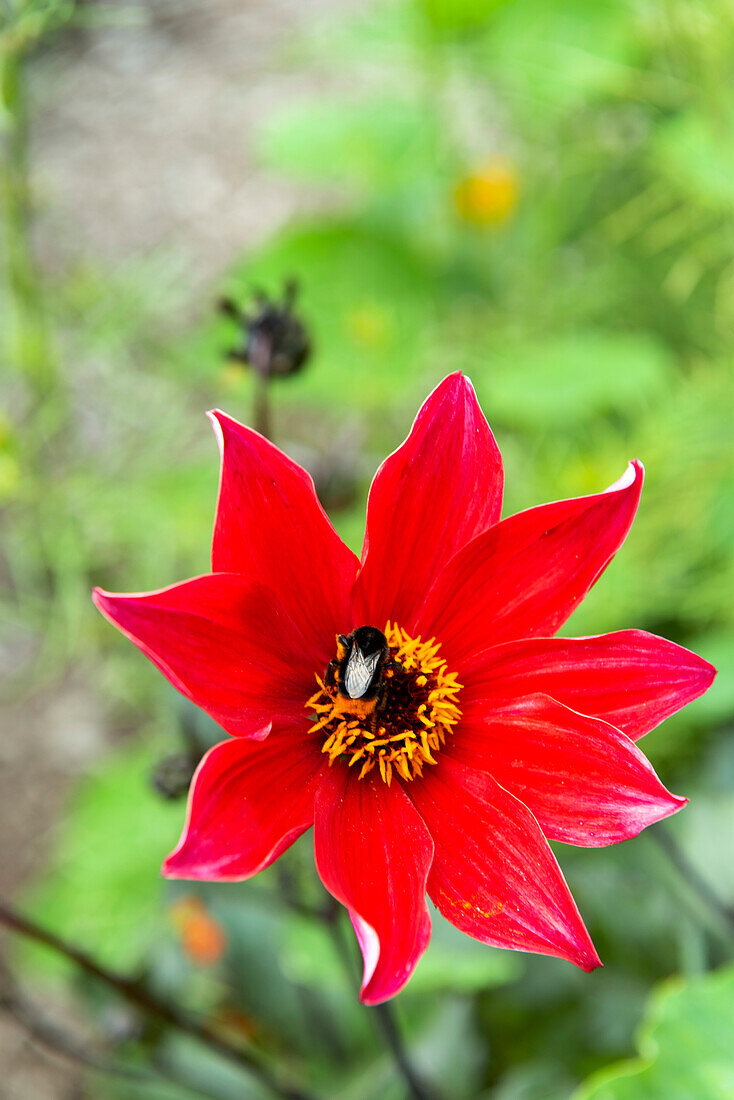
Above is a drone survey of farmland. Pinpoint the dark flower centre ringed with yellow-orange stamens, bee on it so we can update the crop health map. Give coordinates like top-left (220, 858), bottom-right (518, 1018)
top-left (306, 623), bottom-right (462, 787)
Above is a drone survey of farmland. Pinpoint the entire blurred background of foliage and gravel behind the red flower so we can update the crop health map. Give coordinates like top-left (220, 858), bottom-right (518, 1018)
top-left (0, 0), bottom-right (734, 1100)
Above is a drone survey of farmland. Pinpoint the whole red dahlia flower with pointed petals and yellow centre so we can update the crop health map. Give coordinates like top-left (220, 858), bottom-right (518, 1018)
top-left (95, 374), bottom-right (714, 1004)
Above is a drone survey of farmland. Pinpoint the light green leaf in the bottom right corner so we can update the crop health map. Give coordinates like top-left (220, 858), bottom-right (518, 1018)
top-left (573, 966), bottom-right (734, 1100)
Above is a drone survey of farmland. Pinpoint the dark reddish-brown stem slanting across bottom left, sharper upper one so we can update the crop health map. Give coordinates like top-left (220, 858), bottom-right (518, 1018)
top-left (0, 899), bottom-right (315, 1100)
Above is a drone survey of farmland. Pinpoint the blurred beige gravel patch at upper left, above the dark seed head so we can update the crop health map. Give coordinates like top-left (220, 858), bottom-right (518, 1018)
top-left (33, 0), bottom-right (360, 279)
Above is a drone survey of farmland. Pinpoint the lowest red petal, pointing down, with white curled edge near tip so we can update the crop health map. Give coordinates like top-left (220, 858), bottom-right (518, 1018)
top-left (314, 761), bottom-right (434, 1004)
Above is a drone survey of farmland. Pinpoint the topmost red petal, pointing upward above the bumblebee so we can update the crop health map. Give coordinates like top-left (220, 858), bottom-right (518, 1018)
top-left (355, 374), bottom-right (504, 628)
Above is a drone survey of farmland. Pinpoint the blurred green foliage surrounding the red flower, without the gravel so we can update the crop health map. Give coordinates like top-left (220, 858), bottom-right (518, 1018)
top-left (0, 0), bottom-right (734, 1100)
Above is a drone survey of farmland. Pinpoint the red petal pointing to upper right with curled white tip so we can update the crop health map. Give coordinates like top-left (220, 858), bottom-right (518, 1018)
top-left (419, 462), bottom-right (644, 667)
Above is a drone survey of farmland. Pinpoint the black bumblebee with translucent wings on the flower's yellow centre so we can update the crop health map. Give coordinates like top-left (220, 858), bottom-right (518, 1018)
top-left (325, 626), bottom-right (388, 718)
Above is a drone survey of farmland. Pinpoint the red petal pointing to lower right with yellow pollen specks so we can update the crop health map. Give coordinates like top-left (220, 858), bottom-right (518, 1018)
top-left (410, 754), bottom-right (601, 970)
